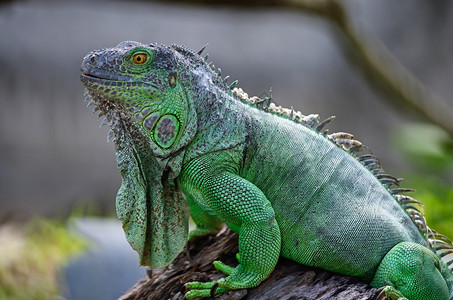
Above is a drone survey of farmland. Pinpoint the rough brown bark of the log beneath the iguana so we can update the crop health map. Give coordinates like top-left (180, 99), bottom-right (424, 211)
top-left (120, 229), bottom-right (378, 300)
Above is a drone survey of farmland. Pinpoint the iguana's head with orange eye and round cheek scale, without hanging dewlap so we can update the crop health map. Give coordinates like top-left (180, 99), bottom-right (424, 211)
top-left (81, 42), bottom-right (200, 157)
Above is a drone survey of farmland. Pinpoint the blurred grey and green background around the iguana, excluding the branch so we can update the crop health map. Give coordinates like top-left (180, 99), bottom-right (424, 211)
top-left (0, 0), bottom-right (453, 299)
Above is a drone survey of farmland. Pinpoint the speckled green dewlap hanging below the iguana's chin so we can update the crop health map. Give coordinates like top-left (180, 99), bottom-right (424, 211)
top-left (116, 127), bottom-right (189, 268)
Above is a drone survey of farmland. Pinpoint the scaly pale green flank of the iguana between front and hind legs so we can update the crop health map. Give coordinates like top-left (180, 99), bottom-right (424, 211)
top-left (240, 108), bottom-right (428, 281)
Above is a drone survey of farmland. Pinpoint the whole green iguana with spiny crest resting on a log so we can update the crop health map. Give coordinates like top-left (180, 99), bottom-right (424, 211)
top-left (81, 41), bottom-right (453, 300)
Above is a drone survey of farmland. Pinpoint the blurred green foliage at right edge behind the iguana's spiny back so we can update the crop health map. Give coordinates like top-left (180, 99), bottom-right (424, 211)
top-left (394, 123), bottom-right (453, 239)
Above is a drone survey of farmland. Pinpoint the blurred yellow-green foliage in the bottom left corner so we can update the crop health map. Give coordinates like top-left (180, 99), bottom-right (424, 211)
top-left (0, 219), bottom-right (87, 300)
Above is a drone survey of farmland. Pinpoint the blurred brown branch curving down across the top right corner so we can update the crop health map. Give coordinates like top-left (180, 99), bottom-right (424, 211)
top-left (157, 0), bottom-right (453, 139)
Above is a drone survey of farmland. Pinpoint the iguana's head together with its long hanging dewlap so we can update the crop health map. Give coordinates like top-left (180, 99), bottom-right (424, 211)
top-left (81, 42), bottom-right (197, 268)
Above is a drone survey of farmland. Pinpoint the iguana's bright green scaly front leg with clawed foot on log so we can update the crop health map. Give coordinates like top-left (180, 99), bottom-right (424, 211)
top-left (180, 159), bottom-right (281, 299)
